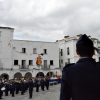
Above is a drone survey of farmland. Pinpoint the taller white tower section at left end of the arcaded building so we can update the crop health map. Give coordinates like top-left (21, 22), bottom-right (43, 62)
top-left (0, 27), bottom-right (14, 79)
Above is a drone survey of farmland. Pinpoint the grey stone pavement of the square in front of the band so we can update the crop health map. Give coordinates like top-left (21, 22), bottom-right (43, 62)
top-left (2, 84), bottom-right (60, 100)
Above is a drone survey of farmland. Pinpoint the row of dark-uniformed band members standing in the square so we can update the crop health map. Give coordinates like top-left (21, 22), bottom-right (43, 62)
top-left (0, 77), bottom-right (50, 99)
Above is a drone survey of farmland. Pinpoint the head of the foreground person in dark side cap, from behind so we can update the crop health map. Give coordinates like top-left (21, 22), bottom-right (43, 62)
top-left (76, 34), bottom-right (94, 57)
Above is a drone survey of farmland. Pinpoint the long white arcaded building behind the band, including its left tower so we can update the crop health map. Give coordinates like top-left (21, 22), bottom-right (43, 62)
top-left (0, 27), bottom-right (61, 79)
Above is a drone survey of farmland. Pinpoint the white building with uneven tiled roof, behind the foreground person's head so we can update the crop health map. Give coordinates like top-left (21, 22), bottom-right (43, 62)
top-left (56, 35), bottom-right (100, 68)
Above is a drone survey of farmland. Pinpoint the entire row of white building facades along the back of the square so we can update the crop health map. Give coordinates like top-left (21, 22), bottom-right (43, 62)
top-left (0, 27), bottom-right (100, 79)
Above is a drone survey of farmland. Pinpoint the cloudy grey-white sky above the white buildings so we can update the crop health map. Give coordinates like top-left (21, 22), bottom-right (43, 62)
top-left (0, 0), bottom-right (100, 42)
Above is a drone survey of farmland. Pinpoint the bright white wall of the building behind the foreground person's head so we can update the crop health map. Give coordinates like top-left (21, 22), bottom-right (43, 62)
top-left (58, 37), bottom-right (100, 70)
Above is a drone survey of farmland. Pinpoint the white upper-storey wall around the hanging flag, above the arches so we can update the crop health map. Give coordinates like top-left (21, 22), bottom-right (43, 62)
top-left (13, 40), bottom-right (59, 69)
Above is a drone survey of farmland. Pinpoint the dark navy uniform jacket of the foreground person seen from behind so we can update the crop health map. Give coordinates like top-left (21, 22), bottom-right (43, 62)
top-left (60, 58), bottom-right (100, 100)
